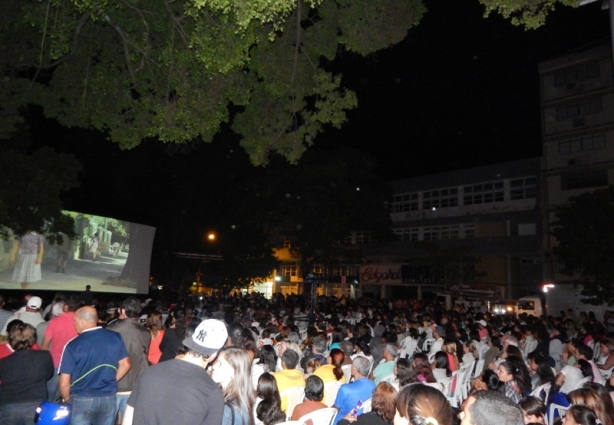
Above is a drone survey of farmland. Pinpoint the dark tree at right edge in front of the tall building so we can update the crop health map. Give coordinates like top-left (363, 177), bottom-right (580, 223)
top-left (552, 186), bottom-right (614, 305)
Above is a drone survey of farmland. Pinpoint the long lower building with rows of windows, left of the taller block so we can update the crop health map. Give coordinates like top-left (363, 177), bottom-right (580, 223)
top-left (361, 158), bottom-right (542, 297)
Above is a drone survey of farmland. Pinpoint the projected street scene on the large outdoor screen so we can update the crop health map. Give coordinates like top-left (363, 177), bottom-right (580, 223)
top-left (0, 211), bottom-right (155, 294)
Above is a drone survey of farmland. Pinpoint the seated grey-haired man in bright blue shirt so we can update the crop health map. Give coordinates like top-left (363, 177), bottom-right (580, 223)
top-left (333, 356), bottom-right (375, 425)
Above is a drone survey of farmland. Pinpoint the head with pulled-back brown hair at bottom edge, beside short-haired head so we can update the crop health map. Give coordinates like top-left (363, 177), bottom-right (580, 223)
top-left (394, 384), bottom-right (453, 425)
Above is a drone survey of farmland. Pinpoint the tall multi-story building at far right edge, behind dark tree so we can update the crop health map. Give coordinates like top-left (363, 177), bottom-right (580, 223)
top-left (539, 43), bottom-right (614, 282)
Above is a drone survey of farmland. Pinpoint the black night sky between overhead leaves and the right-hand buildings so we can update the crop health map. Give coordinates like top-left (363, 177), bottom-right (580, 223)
top-left (325, 0), bottom-right (609, 180)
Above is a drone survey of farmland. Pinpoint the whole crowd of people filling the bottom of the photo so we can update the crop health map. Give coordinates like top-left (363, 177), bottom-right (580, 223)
top-left (0, 293), bottom-right (614, 425)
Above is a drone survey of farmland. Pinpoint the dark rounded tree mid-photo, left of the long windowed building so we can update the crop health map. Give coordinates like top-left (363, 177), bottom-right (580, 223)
top-left (240, 149), bottom-right (391, 271)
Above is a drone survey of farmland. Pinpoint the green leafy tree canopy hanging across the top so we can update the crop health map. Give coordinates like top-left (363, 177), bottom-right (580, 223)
top-left (0, 0), bottom-right (577, 165)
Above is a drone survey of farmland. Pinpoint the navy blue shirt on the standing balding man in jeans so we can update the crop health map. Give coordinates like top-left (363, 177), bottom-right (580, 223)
top-left (60, 327), bottom-right (128, 397)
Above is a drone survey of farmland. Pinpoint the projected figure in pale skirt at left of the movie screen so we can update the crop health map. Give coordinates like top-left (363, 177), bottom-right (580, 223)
top-left (9, 230), bottom-right (45, 288)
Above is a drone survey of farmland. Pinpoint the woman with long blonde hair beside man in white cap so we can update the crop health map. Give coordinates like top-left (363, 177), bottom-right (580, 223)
top-left (211, 347), bottom-right (254, 425)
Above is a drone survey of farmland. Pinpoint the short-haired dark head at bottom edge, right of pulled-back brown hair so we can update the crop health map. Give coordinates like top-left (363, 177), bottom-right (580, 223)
top-left (460, 391), bottom-right (524, 425)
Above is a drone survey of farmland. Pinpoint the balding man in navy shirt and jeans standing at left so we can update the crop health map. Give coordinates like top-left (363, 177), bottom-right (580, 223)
top-left (59, 306), bottom-right (131, 425)
